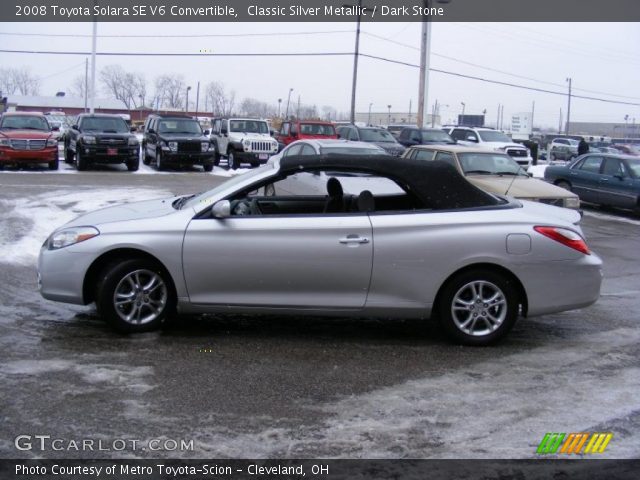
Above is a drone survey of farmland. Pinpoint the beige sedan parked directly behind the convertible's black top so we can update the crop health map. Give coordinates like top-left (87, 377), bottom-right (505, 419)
top-left (404, 145), bottom-right (580, 209)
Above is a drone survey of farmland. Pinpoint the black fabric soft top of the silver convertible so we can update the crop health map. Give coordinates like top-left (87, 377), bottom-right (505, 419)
top-left (280, 154), bottom-right (501, 210)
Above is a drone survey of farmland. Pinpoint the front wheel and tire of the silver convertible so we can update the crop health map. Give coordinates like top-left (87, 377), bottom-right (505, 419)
top-left (95, 259), bottom-right (176, 333)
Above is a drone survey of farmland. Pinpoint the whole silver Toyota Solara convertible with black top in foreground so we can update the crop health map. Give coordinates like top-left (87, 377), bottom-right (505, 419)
top-left (38, 155), bottom-right (602, 345)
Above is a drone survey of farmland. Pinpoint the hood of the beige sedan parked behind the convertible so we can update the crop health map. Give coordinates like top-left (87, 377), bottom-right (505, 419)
top-left (466, 175), bottom-right (576, 199)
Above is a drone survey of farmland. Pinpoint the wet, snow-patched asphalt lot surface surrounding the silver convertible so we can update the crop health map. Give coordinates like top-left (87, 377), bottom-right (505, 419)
top-left (0, 171), bottom-right (640, 458)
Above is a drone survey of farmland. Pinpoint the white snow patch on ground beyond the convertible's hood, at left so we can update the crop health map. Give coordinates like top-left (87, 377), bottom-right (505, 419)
top-left (0, 188), bottom-right (173, 265)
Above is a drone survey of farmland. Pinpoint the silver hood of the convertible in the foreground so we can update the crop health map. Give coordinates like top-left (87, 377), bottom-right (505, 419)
top-left (64, 197), bottom-right (178, 228)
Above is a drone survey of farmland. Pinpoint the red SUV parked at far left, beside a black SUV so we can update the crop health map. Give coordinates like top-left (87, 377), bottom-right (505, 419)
top-left (0, 112), bottom-right (58, 170)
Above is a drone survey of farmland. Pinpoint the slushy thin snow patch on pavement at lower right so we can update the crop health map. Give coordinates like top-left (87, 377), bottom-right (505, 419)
top-left (188, 328), bottom-right (640, 458)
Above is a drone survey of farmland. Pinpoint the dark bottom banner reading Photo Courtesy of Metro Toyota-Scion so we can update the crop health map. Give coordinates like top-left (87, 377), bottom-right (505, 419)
top-left (0, 459), bottom-right (640, 480)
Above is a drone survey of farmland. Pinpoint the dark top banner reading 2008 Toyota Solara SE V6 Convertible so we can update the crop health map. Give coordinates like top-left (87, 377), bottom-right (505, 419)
top-left (0, 0), bottom-right (640, 22)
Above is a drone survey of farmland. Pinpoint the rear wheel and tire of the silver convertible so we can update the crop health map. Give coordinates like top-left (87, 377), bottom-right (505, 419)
top-left (437, 270), bottom-right (519, 346)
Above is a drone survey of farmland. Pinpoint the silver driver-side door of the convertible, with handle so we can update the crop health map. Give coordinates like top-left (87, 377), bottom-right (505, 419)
top-left (183, 172), bottom-right (373, 310)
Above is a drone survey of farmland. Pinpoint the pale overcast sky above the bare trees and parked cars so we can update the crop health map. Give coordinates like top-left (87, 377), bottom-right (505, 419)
top-left (0, 22), bottom-right (640, 127)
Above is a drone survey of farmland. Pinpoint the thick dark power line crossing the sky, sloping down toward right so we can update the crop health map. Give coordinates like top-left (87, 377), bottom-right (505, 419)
top-left (0, 49), bottom-right (640, 106)
